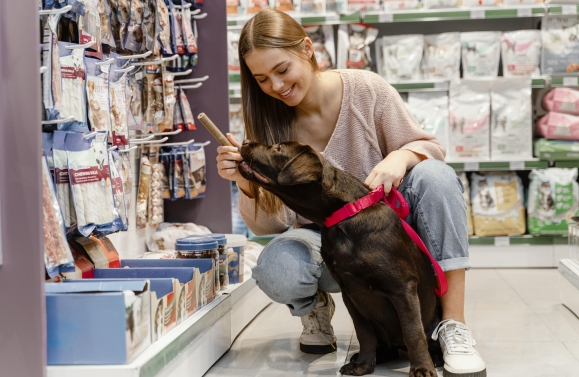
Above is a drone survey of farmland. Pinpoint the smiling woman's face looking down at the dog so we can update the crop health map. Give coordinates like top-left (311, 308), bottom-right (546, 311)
top-left (245, 38), bottom-right (314, 106)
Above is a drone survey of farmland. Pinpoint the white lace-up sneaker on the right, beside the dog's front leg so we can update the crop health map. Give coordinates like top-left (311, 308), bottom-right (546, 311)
top-left (432, 319), bottom-right (487, 377)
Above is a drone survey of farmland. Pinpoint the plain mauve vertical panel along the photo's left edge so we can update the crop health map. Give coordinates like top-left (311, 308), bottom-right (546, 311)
top-left (0, 0), bottom-right (46, 377)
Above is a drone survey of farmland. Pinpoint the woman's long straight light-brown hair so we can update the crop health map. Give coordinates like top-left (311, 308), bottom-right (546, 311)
top-left (238, 8), bottom-right (319, 216)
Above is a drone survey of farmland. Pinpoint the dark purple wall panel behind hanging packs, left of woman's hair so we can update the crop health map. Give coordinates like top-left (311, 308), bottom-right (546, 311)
top-left (165, 0), bottom-right (232, 233)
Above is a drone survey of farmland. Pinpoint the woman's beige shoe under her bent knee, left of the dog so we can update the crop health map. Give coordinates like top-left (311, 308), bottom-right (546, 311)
top-left (300, 292), bottom-right (336, 353)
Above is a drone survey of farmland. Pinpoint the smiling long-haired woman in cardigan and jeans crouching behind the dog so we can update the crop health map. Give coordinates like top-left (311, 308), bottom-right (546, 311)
top-left (217, 9), bottom-right (486, 376)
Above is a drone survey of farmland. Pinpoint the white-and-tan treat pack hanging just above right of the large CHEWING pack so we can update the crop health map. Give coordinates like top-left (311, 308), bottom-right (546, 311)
top-left (86, 59), bottom-right (112, 132)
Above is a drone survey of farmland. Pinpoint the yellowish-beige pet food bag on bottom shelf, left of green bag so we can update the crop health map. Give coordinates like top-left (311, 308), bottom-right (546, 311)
top-left (470, 172), bottom-right (526, 237)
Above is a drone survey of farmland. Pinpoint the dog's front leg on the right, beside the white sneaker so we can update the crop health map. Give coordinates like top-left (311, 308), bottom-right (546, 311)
top-left (390, 281), bottom-right (438, 377)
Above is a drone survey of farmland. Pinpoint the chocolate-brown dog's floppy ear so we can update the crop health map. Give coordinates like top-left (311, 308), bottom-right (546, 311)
top-left (277, 151), bottom-right (323, 186)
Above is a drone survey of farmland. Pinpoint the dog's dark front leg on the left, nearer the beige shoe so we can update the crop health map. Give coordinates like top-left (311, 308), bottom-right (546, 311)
top-left (340, 290), bottom-right (378, 376)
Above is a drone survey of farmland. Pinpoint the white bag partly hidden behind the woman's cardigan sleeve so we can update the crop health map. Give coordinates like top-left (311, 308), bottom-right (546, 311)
top-left (407, 92), bottom-right (449, 150)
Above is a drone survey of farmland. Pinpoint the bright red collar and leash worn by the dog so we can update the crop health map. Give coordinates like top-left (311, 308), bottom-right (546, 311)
top-left (324, 185), bottom-right (448, 296)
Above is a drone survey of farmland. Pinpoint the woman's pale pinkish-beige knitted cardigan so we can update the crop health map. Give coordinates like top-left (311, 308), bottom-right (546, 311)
top-left (239, 69), bottom-right (445, 235)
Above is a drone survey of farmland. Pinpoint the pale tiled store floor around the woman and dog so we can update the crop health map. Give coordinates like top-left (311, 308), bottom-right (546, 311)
top-left (206, 269), bottom-right (579, 377)
